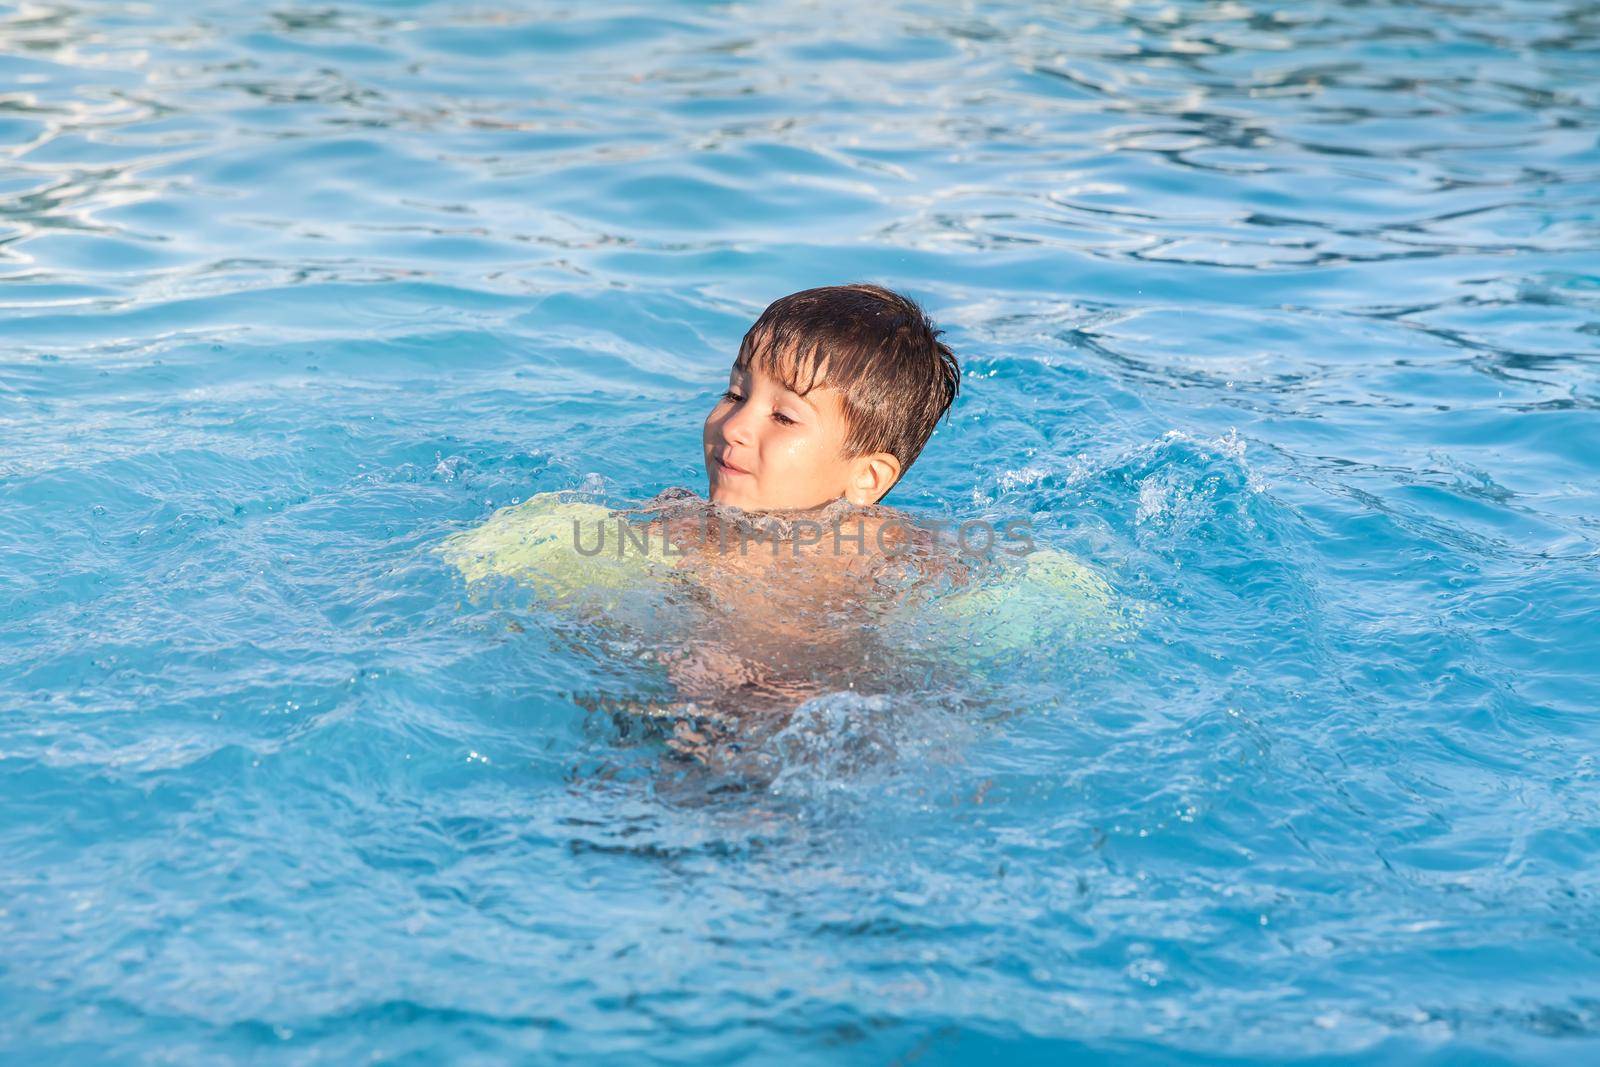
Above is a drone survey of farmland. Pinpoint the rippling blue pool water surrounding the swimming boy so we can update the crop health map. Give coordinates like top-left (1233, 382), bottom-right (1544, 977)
top-left (0, 0), bottom-right (1600, 1065)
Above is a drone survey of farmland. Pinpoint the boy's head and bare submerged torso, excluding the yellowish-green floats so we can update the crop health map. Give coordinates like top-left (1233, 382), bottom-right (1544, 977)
top-left (636, 285), bottom-right (962, 744)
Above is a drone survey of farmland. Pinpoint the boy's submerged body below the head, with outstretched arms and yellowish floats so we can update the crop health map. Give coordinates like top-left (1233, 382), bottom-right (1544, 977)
top-left (440, 490), bottom-right (1125, 764)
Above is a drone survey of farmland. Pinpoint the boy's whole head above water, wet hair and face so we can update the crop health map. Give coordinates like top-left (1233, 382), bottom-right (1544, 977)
top-left (704, 285), bottom-right (962, 510)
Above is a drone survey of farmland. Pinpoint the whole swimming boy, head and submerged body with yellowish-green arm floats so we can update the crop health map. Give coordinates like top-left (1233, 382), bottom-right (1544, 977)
top-left (443, 285), bottom-right (1081, 761)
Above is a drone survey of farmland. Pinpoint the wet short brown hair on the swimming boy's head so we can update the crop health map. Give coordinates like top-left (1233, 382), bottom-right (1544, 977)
top-left (734, 285), bottom-right (962, 477)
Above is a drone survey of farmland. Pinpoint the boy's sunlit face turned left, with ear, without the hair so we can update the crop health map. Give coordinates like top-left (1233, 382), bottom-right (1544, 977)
top-left (702, 363), bottom-right (864, 510)
